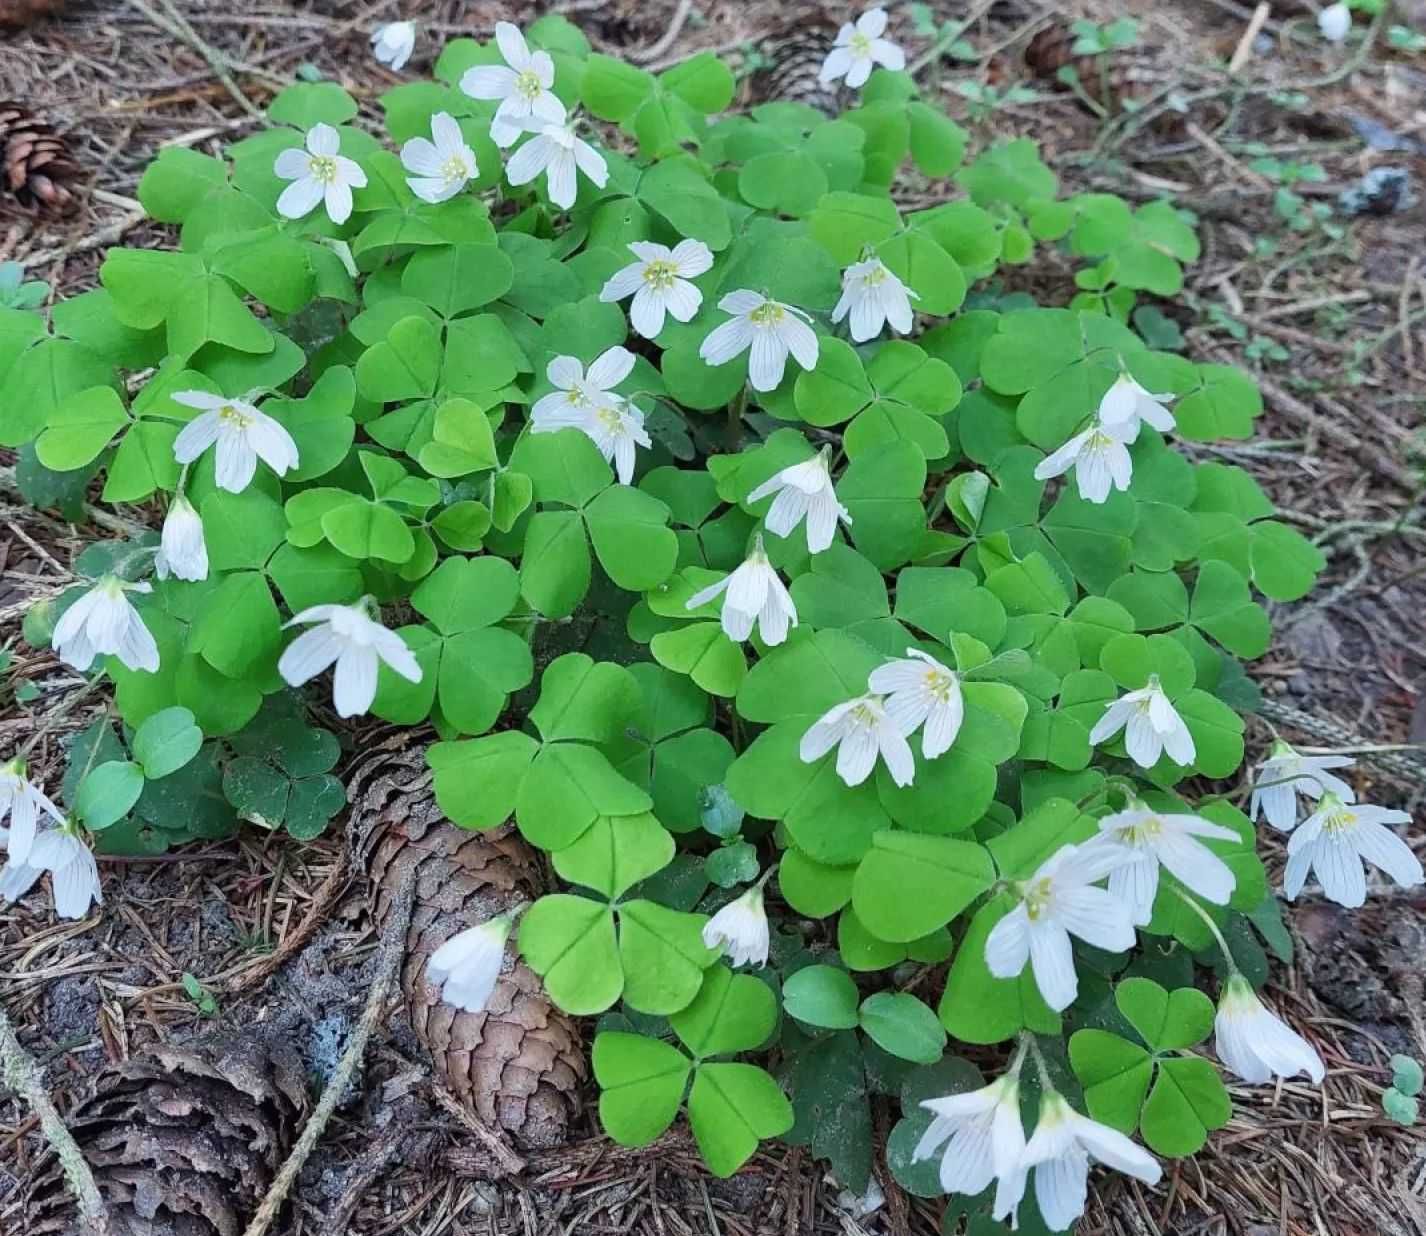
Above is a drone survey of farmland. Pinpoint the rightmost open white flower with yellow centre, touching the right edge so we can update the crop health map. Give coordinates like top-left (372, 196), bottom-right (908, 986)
top-left (1282, 790), bottom-right (1423, 910)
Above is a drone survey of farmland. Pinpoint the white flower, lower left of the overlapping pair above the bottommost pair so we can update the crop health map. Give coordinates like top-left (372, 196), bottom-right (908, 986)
top-left (985, 843), bottom-right (1134, 1012)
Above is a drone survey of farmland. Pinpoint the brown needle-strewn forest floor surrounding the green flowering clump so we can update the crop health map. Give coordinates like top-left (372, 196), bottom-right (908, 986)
top-left (0, 0), bottom-right (1426, 1236)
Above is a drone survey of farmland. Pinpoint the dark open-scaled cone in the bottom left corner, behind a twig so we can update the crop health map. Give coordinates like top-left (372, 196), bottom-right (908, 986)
top-left (28, 1035), bottom-right (307, 1236)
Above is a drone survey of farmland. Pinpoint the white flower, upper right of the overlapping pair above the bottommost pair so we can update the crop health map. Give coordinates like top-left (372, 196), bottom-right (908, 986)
top-left (1099, 801), bottom-right (1242, 927)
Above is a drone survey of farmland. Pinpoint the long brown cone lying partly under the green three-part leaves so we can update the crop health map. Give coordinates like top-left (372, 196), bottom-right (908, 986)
top-left (348, 731), bottom-right (586, 1146)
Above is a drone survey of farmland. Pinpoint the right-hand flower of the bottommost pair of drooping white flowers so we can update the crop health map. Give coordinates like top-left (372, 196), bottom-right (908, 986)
top-left (1020, 1091), bottom-right (1164, 1232)
